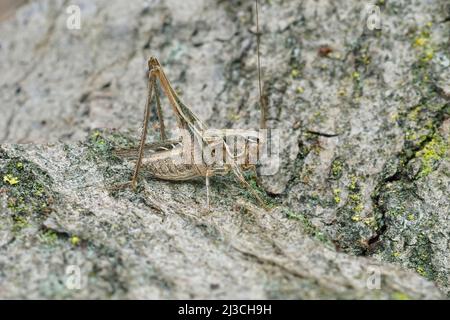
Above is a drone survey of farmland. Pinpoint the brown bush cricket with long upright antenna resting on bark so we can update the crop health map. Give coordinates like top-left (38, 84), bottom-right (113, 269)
top-left (115, 0), bottom-right (266, 208)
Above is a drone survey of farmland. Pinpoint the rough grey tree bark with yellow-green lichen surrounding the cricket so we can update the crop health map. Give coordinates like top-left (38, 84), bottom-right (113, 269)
top-left (0, 0), bottom-right (450, 299)
